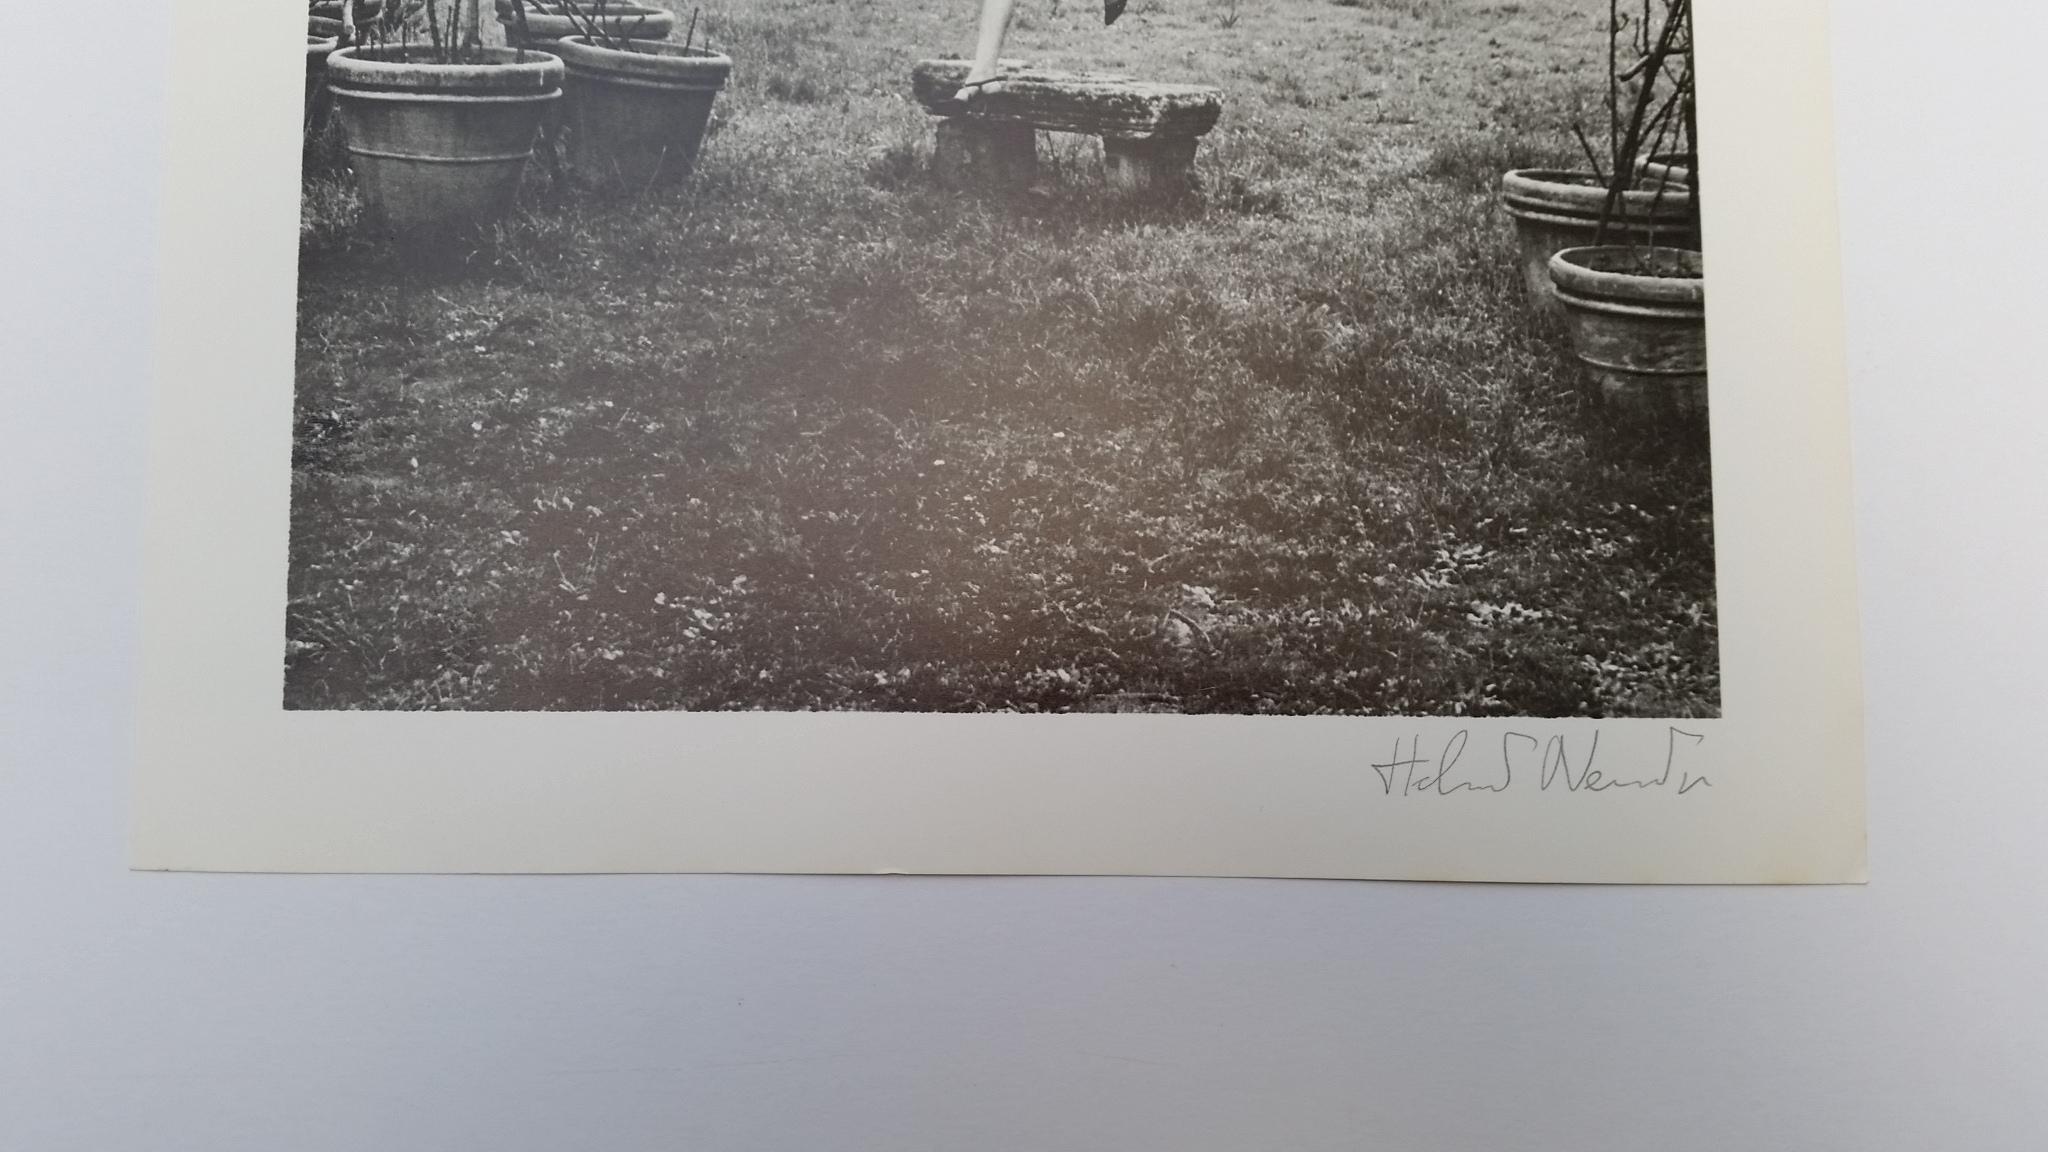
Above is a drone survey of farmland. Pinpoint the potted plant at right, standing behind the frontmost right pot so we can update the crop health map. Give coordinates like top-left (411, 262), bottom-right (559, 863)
top-left (1501, 0), bottom-right (1700, 316)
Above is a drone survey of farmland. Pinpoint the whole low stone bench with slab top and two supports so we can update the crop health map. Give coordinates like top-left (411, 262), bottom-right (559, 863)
top-left (909, 59), bottom-right (1223, 195)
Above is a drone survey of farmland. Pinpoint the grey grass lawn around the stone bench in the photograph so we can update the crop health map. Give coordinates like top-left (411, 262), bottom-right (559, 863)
top-left (285, 0), bottom-right (1720, 715)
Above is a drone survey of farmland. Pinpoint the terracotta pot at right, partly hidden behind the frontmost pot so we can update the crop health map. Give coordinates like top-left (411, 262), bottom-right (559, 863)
top-left (1501, 168), bottom-right (1700, 316)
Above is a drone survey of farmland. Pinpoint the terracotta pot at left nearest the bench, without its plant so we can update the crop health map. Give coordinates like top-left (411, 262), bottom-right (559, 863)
top-left (555, 37), bottom-right (733, 191)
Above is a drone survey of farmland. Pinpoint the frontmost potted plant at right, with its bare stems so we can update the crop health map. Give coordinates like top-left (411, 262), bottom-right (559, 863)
top-left (1546, 0), bottom-right (1706, 418)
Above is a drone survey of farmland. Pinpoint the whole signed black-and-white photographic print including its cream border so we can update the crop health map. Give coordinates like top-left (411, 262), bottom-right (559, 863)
top-left (131, 0), bottom-right (1864, 883)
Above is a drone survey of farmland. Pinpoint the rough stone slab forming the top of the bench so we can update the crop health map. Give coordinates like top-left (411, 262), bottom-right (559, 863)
top-left (911, 59), bottom-right (1223, 139)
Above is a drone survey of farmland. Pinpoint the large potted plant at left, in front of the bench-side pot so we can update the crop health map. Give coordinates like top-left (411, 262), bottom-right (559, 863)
top-left (328, 0), bottom-right (563, 234)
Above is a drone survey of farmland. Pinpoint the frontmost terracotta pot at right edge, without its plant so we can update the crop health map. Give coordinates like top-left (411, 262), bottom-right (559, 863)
top-left (1550, 246), bottom-right (1706, 420)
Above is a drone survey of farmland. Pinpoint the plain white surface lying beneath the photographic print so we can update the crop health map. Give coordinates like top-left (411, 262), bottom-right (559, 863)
top-left (0, 0), bottom-right (2048, 1152)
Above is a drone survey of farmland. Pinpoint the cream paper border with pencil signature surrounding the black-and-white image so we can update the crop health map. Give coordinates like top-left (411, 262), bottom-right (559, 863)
top-left (131, 0), bottom-right (1864, 883)
